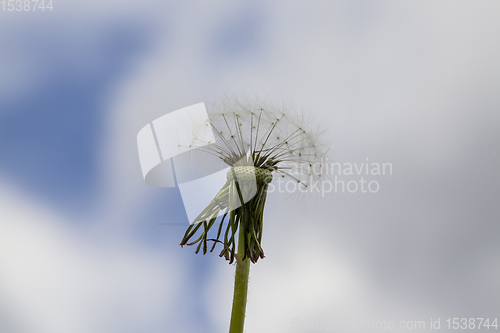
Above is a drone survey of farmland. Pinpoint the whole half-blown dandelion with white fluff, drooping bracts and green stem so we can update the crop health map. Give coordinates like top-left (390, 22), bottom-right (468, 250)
top-left (180, 98), bottom-right (327, 333)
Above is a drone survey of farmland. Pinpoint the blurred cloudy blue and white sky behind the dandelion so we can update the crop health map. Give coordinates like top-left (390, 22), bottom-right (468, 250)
top-left (0, 0), bottom-right (500, 333)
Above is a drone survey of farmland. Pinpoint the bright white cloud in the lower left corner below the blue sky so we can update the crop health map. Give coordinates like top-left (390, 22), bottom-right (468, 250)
top-left (0, 182), bottom-right (180, 333)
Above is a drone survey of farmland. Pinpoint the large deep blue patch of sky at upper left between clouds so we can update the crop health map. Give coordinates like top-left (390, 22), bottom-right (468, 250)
top-left (0, 18), bottom-right (152, 212)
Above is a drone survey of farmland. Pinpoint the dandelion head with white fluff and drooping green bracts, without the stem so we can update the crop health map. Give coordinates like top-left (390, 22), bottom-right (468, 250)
top-left (181, 97), bottom-right (328, 263)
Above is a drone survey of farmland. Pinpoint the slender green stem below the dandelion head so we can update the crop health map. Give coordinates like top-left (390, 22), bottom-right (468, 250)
top-left (229, 219), bottom-right (254, 333)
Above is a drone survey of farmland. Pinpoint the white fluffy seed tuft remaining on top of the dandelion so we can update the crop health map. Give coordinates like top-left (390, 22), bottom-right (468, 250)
top-left (193, 97), bottom-right (328, 189)
